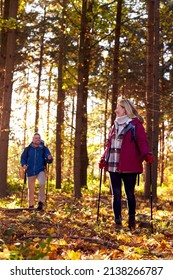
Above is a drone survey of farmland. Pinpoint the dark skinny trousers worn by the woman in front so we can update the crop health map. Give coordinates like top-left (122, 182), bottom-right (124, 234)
top-left (109, 172), bottom-right (137, 221)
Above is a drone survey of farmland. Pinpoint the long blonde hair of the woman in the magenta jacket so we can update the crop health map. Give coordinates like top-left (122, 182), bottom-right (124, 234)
top-left (118, 98), bottom-right (144, 123)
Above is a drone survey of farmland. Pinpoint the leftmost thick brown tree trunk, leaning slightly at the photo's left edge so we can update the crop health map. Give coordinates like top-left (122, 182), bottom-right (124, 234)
top-left (0, 0), bottom-right (18, 195)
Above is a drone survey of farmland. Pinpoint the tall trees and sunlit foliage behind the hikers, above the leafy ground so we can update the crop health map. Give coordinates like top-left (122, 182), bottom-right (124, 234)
top-left (0, 0), bottom-right (173, 197)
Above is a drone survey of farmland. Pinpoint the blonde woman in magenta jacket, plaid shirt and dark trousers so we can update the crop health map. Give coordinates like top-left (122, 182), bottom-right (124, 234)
top-left (99, 99), bottom-right (154, 229)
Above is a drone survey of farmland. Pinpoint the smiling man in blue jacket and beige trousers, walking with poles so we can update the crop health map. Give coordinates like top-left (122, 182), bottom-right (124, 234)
top-left (20, 133), bottom-right (53, 210)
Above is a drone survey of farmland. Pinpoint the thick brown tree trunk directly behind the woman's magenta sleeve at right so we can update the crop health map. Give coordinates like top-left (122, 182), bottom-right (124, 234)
top-left (144, 0), bottom-right (159, 198)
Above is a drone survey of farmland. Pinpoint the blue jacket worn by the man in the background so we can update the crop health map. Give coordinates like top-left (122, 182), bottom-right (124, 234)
top-left (20, 143), bottom-right (53, 177)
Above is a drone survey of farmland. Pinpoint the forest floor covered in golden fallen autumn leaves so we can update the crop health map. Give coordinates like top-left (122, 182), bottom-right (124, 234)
top-left (0, 182), bottom-right (173, 260)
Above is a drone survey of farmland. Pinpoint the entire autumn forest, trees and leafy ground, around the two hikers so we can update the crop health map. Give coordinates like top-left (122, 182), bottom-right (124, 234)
top-left (0, 0), bottom-right (173, 260)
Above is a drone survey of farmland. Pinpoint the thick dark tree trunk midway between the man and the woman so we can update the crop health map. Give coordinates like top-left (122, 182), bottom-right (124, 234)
top-left (74, 0), bottom-right (93, 198)
